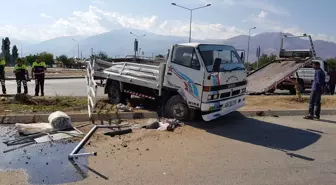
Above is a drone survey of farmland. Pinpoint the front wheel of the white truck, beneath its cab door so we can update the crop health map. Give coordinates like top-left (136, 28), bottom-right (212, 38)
top-left (164, 95), bottom-right (195, 121)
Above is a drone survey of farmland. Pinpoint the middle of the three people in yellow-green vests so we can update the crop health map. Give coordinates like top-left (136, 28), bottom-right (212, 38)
top-left (14, 58), bottom-right (29, 94)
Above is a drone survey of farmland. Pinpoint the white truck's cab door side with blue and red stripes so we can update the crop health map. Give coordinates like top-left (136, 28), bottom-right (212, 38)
top-left (165, 45), bottom-right (204, 108)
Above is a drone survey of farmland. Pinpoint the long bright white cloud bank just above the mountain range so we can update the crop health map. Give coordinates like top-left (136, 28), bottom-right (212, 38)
top-left (0, 6), bottom-right (244, 40)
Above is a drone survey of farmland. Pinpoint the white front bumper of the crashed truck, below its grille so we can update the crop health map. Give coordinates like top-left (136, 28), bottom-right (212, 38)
top-left (202, 95), bottom-right (245, 121)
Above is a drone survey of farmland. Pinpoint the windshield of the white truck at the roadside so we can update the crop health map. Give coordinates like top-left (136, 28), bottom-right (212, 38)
top-left (198, 45), bottom-right (245, 72)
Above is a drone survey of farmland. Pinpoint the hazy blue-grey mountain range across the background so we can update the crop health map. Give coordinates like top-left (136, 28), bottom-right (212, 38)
top-left (6, 29), bottom-right (336, 62)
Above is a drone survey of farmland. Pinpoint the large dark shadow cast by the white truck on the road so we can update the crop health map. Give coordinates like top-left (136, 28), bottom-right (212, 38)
top-left (187, 112), bottom-right (321, 153)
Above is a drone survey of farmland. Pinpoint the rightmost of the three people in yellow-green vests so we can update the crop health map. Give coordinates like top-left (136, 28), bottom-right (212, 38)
top-left (32, 58), bottom-right (47, 96)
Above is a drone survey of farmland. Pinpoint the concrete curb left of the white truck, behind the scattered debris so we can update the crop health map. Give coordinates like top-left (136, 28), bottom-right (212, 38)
top-left (0, 112), bottom-right (158, 124)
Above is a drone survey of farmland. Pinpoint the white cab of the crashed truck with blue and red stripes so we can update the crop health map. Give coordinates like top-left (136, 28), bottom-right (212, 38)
top-left (163, 43), bottom-right (247, 121)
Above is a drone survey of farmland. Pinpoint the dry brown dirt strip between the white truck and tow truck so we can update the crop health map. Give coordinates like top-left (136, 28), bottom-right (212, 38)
top-left (239, 96), bottom-right (336, 110)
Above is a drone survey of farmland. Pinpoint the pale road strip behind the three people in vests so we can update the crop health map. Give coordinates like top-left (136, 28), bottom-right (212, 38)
top-left (0, 78), bottom-right (104, 96)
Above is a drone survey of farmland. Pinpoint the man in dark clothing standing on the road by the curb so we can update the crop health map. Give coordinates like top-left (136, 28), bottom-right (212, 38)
top-left (304, 62), bottom-right (325, 119)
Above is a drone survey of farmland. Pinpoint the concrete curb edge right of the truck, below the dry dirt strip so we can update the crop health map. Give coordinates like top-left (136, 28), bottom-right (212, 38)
top-left (238, 109), bottom-right (336, 117)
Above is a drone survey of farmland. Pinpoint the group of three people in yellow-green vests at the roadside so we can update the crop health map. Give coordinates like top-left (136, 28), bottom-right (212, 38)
top-left (0, 58), bottom-right (47, 96)
